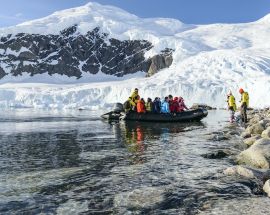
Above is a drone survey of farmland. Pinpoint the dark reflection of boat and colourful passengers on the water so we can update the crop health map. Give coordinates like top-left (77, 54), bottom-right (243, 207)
top-left (112, 118), bottom-right (205, 164)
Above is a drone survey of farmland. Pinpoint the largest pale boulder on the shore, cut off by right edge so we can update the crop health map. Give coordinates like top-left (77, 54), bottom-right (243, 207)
top-left (237, 138), bottom-right (270, 169)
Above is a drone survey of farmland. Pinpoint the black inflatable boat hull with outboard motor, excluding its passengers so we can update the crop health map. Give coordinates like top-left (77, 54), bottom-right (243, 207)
top-left (101, 104), bottom-right (208, 122)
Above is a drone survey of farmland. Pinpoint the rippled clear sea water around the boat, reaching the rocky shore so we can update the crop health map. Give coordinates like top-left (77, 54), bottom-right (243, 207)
top-left (0, 109), bottom-right (267, 214)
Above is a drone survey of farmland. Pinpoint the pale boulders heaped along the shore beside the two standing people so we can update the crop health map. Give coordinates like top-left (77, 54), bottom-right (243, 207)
top-left (223, 108), bottom-right (270, 197)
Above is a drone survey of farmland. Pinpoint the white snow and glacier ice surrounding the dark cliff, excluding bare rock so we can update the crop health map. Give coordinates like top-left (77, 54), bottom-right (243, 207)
top-left (0, 3), bottom-right (270, 109)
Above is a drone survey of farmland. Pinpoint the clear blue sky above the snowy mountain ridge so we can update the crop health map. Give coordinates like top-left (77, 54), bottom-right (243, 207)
top-left (0, 0), bottom-right (270, 27)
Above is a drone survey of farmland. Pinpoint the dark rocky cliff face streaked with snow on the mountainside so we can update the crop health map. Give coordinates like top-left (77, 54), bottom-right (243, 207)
top-left (0, 25), bottom-right (172, 79)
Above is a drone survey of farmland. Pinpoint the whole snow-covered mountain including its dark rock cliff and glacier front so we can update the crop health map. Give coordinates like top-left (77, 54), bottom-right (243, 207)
top-left (0, 3), bottom-right (270, 109)
